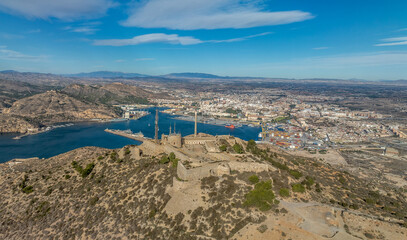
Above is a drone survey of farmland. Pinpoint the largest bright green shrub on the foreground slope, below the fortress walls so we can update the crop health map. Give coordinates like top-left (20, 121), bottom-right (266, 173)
top-left (243, 181), bottom-right (275, 211)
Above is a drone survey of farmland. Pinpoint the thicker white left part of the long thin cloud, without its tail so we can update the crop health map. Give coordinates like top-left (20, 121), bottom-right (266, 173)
top-left (93, 33), bottom-right (202, 47)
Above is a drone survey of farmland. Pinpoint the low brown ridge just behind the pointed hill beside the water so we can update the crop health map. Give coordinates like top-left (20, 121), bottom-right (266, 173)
top-left (62, 83), bottom-right (168, 105)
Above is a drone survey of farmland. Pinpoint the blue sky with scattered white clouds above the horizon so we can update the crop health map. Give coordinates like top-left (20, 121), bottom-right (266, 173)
top-left (0, 0), bottom-right (407, 80)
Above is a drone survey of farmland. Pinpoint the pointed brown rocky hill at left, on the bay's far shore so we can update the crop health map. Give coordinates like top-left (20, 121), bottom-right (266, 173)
top-left (4, 91), bottom-right (119, 124)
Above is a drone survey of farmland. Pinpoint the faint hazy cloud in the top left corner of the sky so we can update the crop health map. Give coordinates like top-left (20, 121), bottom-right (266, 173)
top-left (0, 0), bottom-right (116, 20)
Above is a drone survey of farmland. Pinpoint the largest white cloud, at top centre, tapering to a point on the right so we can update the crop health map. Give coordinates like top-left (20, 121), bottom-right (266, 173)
top-left (122, 0), bottom-right (313, 30)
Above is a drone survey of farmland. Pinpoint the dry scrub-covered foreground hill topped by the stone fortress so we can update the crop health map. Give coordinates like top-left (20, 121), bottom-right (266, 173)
top-left (0, 136), bottom-right (407, 240)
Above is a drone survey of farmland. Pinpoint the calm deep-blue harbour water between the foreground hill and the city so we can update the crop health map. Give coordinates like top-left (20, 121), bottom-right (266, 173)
top-left (0, 109), bottom-right (261, 162)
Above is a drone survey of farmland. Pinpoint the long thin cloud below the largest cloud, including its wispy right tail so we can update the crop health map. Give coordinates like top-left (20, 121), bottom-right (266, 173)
top-left (93, 32), bottom-right (271, 47)
